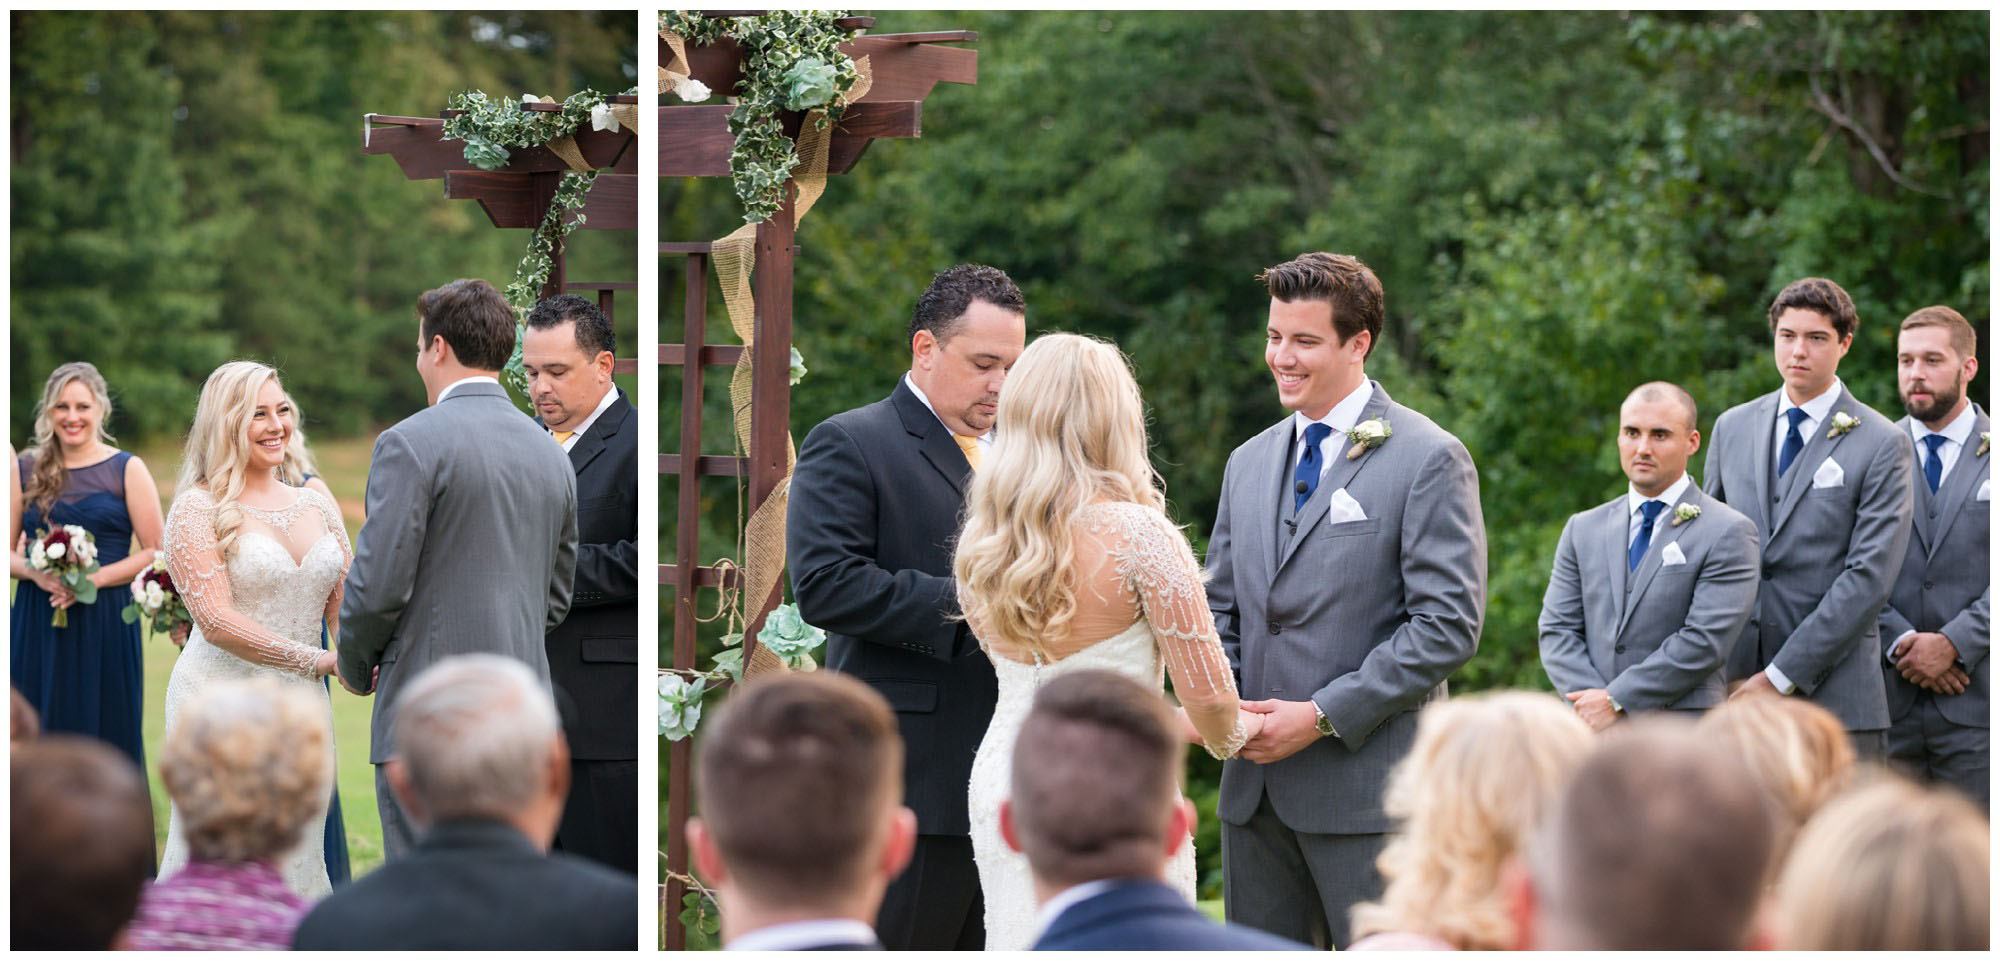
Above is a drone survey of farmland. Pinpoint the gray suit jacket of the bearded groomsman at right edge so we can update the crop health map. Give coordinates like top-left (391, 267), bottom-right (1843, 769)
top-left (1882, 404), bottom-right (1994, 727)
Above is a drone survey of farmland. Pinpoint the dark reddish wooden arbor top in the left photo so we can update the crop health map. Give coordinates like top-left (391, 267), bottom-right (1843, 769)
top-left (362, 94), bottom-right (638, 374)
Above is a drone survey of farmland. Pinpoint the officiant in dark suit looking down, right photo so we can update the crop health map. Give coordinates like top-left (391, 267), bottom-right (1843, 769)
top-left (786, 264), bottom-right (1028, 951)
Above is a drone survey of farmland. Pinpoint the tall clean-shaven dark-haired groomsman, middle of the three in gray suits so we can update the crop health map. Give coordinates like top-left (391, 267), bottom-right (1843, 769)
top-left (1704, 276), bottom-right (1910, 757)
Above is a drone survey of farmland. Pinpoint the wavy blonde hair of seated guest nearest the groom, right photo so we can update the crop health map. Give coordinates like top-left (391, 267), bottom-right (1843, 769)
top-left (1354, 691), bottom-right (1594, 951)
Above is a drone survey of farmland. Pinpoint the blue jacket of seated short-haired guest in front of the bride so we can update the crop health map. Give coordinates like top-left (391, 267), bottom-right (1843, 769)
top-left (1034, 881), bottom-right (1310, 951)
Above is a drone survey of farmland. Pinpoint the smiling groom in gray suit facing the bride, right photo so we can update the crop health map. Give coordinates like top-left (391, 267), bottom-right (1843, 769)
top-left (1208, 252), bottom-right (1486, 947)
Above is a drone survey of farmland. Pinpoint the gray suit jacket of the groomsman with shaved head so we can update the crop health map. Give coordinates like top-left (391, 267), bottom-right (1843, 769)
top-left (1540, 485), bottom-right (1758, 713)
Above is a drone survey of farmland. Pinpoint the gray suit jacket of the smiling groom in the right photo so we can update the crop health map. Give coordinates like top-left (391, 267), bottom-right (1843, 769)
top-left (1208, 384), bottom-right (1486, 835)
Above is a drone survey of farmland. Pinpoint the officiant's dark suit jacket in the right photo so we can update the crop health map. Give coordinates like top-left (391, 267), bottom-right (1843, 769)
top-left (784, 384), bottom-right (996, 835)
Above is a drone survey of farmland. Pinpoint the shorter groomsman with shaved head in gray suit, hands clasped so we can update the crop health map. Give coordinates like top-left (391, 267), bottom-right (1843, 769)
top-left (1542, 382), bottom-right (1758, 731)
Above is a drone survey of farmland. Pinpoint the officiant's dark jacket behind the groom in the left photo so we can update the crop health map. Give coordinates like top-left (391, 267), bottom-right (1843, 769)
top-left (548, 390), bottom-right (638, 761)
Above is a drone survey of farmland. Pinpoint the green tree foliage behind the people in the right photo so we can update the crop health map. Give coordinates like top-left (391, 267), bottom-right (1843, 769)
top-left (662, 12), bottom-right (1990, 904)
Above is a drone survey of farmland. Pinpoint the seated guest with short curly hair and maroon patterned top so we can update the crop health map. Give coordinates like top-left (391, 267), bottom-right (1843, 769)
top-left (128, 679), bottom-right (332, 951)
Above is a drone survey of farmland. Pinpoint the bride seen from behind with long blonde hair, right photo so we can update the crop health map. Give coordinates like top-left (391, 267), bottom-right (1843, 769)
top-left (954, 334), bottom-right (1262, 951)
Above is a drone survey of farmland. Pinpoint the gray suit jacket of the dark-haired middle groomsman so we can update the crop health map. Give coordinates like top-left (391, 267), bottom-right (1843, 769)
top-left (1702, 386), bottom-right (1910, 731)
